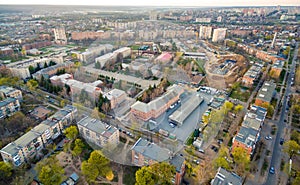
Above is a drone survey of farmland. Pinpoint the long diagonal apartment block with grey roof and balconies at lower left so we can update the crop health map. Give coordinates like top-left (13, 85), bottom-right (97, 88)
top-left (0, 105), bottom-right (77, 166)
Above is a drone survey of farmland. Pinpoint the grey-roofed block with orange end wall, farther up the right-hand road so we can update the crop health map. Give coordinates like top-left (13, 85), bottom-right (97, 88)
top-left (255, 80), bottom-right (276, 107)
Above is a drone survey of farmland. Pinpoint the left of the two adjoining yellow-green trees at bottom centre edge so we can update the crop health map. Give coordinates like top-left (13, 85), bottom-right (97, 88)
top-left (135, 166), bottom-right (157, 185)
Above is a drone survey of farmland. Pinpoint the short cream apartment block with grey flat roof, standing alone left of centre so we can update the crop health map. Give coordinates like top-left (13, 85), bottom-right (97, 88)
top-left (77, 116), bottom-right (119, 149)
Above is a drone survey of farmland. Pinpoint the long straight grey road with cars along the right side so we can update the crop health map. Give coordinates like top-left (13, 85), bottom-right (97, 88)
top-left (265, 43), bottom-right (298, 185)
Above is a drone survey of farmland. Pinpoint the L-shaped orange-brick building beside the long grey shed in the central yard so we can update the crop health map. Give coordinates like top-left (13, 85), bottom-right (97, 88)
top-left (131, 84), bottom-right (184, 121)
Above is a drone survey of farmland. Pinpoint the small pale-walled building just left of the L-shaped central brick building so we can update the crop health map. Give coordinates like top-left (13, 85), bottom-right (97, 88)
top-left (103, 89), bottom-right (127, 109)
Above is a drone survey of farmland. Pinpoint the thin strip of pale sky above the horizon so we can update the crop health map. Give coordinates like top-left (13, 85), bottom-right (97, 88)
top-left (0, 0), bottom-right (300, 6)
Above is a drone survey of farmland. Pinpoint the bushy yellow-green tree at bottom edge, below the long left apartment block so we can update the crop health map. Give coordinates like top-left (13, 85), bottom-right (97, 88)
top-left (35, 157), bottom-right (65, 185)
